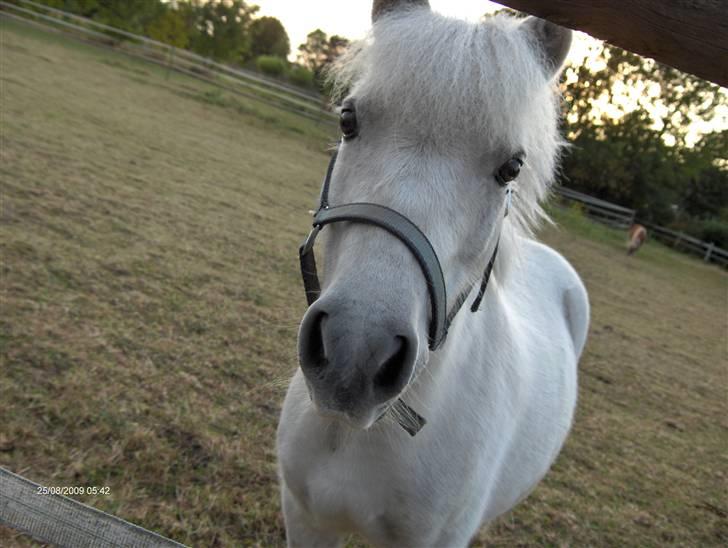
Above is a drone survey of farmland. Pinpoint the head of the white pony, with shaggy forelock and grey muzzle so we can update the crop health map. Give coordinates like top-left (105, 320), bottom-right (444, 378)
top-left (299, 0), bottom-right (571, 428)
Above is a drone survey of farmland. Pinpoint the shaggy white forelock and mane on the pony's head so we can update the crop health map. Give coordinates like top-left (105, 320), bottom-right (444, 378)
top-left (329, 8), bottom-right (562, 264)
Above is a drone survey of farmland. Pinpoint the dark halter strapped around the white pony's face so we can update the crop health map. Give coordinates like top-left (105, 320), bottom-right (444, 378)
top-left (298, 147), bottom-right (510, 436)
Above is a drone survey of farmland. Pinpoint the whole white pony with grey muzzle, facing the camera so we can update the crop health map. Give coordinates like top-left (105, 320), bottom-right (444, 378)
top-left (277, 0), bottom-right (589, 547)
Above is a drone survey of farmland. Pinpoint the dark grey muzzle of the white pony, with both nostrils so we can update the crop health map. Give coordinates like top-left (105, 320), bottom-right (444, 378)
top-left (299, 299), bottom-right (417, 427)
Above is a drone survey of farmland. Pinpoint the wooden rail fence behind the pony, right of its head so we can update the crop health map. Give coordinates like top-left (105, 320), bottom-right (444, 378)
top-left (554, 186), bottom-right (728, 267)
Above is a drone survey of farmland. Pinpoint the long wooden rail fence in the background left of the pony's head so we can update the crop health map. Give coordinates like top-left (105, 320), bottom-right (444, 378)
top-left (0, 0), bottom-right (338, 127)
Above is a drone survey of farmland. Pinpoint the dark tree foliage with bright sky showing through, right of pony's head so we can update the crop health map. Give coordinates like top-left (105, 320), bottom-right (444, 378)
top-left (562, 44), bottom-right (728, 231)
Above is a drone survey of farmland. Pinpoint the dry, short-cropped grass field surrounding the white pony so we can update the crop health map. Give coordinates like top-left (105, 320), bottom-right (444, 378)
top-left (0, 19), bottom-right (728, 546)
